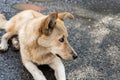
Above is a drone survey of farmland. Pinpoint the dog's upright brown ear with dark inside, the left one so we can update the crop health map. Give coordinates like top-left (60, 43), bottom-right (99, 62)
top-left (42, 12), bottom-right (58, 36)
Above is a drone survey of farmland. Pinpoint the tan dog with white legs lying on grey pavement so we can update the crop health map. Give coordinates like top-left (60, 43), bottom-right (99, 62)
top-left (0, 10), bottom-right (77, 80)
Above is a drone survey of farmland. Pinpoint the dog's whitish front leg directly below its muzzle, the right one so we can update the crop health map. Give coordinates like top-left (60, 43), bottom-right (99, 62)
top-left (49, 57), bottom-right (66, 80)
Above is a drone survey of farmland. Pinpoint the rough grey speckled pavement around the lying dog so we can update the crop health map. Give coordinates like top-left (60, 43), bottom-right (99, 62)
top-left (0, 0), bottom-right (120, 80)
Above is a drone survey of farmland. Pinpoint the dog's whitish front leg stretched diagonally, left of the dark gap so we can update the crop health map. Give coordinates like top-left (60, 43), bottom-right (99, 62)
top-left (23, 61), bottom-right (46, 80)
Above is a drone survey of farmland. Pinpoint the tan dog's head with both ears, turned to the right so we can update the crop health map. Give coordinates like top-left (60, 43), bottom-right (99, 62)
top-left (38, 12), bottom-right (77, 60)
